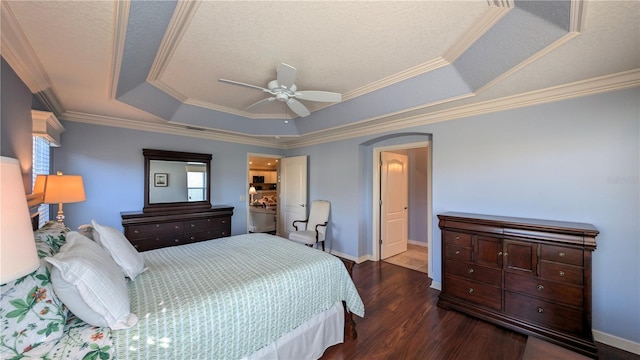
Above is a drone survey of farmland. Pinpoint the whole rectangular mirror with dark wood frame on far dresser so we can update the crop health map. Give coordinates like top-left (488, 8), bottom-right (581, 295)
top-left (142, 149), bottom-right (212, 212)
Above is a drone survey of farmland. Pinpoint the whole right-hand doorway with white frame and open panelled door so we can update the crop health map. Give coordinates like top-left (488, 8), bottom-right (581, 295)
top-left (372, 141), bottom-right (433, 273)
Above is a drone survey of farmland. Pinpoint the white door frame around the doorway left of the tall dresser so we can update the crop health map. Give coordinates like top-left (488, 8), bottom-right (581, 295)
top-left (371, 140), bottom-right (433, 274)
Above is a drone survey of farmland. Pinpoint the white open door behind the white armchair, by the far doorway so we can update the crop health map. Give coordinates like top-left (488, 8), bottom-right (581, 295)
top-left (278, 156), bottom-right (307, 238)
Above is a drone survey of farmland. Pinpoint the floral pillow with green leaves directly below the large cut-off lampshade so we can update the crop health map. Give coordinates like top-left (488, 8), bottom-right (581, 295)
top-left (0, 258), bottom-right (67, 359)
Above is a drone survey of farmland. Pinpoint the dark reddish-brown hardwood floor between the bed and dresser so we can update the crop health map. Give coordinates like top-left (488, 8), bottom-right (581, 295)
top-left (321, 261), bottom-right (640, 360)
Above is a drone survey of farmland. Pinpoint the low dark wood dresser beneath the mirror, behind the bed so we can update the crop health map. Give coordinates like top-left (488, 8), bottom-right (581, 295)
top-left (120, 205), bottom-right (233, 251)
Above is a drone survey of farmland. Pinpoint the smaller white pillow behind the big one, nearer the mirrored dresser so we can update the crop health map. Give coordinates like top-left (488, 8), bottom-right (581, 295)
top-left (91, 220), bottom-right (146, 280)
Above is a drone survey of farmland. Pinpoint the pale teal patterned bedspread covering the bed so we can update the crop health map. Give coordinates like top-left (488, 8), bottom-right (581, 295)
top-left (112, 234), bottom-right (364, 359)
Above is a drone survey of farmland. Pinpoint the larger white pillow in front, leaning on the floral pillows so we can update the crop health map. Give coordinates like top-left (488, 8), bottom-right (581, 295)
top-left (45, 231), bottom-right (138, 330)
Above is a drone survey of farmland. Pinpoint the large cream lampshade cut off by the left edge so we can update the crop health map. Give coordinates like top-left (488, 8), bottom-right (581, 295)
top-left (0, 156), bottom-right (40, 284)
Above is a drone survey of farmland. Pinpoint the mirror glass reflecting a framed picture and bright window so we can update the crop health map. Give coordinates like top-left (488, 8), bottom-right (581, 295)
top-left (149, 160), bottom-right (207, 204)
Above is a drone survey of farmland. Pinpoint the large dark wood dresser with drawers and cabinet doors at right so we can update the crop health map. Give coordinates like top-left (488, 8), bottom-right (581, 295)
top-left (438, 213), bottom-right (598, 358)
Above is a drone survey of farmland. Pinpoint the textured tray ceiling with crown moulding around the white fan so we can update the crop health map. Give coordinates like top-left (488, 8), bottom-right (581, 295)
top-left (1, 0), bottom-right (640, 146)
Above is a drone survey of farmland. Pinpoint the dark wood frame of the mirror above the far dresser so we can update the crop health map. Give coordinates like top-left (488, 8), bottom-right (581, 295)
top-left (142, 149), bottom-right (212, 213)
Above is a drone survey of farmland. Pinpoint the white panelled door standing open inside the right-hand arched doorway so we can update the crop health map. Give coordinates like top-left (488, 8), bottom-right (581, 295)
top-left (380, 152), bottom-right (409, 259)
